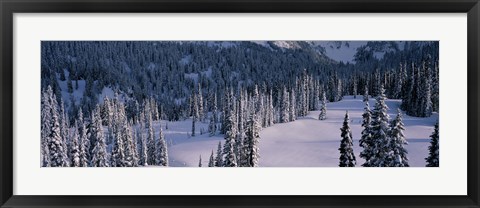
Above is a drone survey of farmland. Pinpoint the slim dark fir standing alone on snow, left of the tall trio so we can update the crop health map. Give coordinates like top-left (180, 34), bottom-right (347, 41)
top-left (338, 111), bottom-right (356, 167)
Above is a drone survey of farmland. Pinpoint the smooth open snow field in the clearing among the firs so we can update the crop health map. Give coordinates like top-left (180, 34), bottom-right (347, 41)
top-left (163, 96), bottom-right (438, 167)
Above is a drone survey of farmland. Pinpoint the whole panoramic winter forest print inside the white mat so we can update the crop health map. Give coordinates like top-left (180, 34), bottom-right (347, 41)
top-left (40, 41), bottom-right (440, 168)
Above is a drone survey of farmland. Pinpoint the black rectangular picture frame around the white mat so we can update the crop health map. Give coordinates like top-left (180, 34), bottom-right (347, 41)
top-left (0, 0), bottom-right (480, 207)
